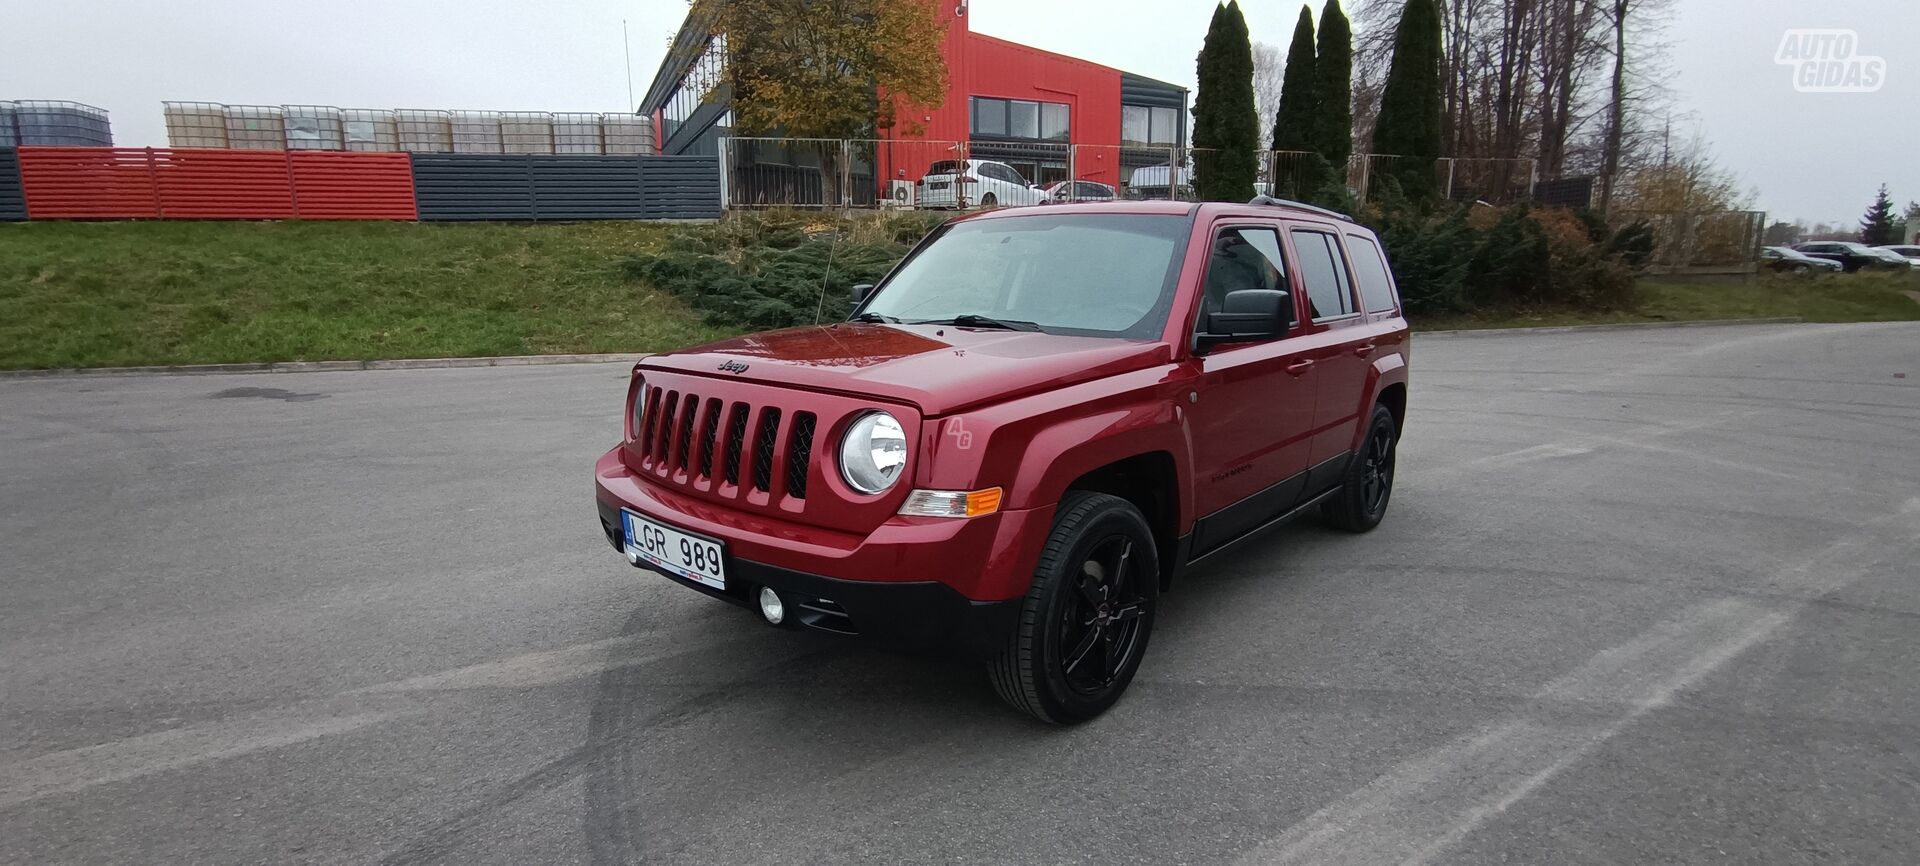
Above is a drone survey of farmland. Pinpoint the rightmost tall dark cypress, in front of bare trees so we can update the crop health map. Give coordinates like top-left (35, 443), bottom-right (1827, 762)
top-left (1373, 0), bottom-right (1442, 200)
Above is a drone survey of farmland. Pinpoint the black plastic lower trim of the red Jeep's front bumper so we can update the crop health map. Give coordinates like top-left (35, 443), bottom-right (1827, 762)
top-left (597, 503), bottom-right (1021, 657)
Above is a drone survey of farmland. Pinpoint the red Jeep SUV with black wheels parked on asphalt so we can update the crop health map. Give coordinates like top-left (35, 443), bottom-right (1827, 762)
top-left (593, 198), bottom-right (1409, 724)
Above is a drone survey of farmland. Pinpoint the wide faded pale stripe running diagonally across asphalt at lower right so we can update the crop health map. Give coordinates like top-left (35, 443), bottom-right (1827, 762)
top-left (1238, 499), bottom-right (1920, 864)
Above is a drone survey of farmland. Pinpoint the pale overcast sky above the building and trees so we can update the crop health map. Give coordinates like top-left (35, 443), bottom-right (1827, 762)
top-left (0, 0), bottom-right (1920, 221)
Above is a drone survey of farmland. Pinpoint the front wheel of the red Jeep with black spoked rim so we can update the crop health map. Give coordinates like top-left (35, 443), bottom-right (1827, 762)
top-left (987, 490), bottom-right (1160, 724)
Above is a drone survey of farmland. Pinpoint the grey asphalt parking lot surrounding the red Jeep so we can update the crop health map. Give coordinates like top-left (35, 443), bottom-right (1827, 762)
top-left (0, 325), bottom-right (1920, 864)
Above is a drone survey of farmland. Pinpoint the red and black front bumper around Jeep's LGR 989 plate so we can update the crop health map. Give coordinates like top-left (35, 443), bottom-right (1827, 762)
top-left (595, 449), bottom-right (1052, 655)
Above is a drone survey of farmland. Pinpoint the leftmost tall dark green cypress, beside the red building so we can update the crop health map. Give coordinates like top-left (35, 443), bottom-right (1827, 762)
top-left (1194, 0), bottom-right (1260, 202)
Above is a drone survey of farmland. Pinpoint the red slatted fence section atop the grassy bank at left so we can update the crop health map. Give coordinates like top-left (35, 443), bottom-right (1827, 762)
top-left (19, 148), bottom-right (419, 219)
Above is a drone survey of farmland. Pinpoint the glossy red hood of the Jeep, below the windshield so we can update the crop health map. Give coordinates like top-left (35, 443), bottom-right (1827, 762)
top-left (639, 323), bottom-right (1171, 415)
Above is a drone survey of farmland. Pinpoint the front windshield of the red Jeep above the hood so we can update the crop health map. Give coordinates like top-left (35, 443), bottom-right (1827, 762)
top-left (862, 213), bottom-right (1190, 340)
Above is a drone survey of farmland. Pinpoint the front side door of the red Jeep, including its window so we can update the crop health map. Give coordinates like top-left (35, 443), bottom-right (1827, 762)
top-left (1188, 225), bottom-right (1315, 555)
